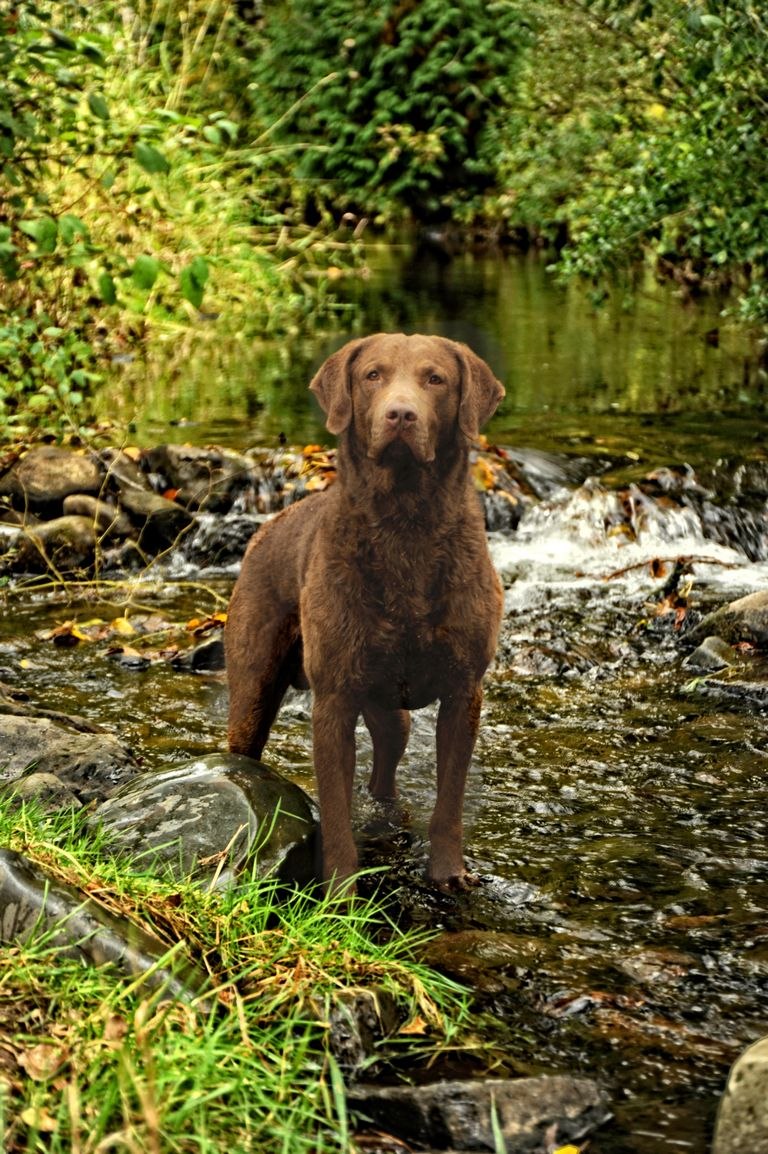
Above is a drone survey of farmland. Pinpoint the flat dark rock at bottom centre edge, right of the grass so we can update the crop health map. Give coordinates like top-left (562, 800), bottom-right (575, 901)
top-left (347, 1076), bottom-right (610, 1154)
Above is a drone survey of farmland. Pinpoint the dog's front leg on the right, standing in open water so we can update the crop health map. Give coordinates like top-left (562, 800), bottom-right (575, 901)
top-left (428, 684), bottom-right (483, 886)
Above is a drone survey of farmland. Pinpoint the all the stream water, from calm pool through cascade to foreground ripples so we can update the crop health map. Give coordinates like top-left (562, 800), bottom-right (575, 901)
top-left (8, 250), bottom-right (768, 1154)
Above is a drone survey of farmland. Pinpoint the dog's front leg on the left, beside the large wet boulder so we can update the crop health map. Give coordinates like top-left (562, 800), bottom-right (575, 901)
top-left (313, 694), bottom-right (359, 889)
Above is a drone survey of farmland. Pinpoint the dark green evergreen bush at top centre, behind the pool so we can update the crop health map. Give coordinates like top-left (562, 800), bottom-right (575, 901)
top-left (254, 0), bottom-right (525, 220)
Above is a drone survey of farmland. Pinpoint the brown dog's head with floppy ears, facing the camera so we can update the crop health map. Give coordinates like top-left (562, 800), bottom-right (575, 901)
top-left (309, 332), bottom-right (504, 464)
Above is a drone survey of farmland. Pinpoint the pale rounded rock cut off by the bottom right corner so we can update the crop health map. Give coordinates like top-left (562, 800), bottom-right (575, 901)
top-left (713, 1037), bottom-right (768, 1154)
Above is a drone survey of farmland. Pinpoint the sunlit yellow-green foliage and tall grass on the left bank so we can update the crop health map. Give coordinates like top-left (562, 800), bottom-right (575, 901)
top-left (0, 0), bottom-right (359, 433)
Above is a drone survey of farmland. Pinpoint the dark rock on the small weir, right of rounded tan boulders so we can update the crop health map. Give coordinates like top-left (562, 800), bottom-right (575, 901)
top-left (143, 444), bottom-right (253, 512)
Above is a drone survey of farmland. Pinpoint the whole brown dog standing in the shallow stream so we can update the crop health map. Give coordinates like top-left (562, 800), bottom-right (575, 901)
top-left (226, 334), bottom-right (504, 885)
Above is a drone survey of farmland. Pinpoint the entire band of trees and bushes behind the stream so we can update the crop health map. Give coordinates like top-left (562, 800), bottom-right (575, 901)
top-left (0, 0), bottom-right (768, 437)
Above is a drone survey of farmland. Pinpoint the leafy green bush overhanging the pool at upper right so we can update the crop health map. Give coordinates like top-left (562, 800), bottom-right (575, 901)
top-left (502, 0), bottom-right (768, 321)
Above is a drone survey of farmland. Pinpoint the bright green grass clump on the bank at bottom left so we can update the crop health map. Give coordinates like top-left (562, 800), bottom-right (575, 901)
top-left (0, 800), bottom-right (467, 1154)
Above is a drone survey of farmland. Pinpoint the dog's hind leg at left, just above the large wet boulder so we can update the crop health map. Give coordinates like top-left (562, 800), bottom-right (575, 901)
top-left (225, 602), bottom-right (301, 758)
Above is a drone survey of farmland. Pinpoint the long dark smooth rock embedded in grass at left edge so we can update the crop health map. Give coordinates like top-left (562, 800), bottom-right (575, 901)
top-left (0, 849), bottom-right (206, 1001)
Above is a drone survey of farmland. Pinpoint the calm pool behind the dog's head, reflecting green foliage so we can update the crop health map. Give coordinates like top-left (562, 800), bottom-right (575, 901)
top-left (101, 246), bottom-right (766, 459)
